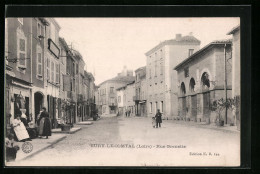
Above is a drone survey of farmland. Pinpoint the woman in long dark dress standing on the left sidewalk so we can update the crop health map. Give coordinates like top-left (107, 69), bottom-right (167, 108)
top-left (39, 107), bottom-right (51, 139)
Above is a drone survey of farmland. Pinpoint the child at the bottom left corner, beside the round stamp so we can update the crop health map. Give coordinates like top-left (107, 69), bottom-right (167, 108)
top-left (5, 133), bottom-right (20, 162)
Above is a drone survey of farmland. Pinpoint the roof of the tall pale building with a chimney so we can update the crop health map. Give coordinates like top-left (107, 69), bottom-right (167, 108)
top-left (145, 35), bottom-right (200, 56)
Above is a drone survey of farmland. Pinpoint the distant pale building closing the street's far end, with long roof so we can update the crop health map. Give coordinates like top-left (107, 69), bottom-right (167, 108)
top-left (97, 67), bottom-right (134, 116)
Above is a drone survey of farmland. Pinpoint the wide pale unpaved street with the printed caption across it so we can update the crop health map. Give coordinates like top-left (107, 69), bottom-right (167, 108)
top-left (11, 116), bottom-right (240, 166)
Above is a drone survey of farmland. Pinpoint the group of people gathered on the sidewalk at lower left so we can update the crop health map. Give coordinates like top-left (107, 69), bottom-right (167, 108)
top-left (5, 107), bottom-right (51, 162)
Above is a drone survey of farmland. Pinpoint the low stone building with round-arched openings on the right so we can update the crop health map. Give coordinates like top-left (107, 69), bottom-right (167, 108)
top-left (174, 40), bottom-right (233, 123)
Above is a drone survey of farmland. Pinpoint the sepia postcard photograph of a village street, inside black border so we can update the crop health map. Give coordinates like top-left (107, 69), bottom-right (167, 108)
top-left (4, 17), bottom-right (241, 167)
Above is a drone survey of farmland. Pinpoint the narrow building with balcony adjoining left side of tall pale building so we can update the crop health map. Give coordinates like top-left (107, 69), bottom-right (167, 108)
top-left (134, 66), bottom-right (147, 116)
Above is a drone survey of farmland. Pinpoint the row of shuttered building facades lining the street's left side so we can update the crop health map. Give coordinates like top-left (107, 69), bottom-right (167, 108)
top-left (5, 18), bottom-right (95, 132)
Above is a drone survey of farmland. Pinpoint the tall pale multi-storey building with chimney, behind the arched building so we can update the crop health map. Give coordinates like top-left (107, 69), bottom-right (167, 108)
top-left (145, 33), bottom-right (200, 118)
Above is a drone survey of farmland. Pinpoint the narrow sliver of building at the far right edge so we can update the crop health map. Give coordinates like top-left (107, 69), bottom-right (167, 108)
top-left (227, 25), bottom-right (241, 130)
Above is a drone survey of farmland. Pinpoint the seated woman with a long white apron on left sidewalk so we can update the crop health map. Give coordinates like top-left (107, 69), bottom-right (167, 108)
top-left (11, 115), bottom-right (31, 142)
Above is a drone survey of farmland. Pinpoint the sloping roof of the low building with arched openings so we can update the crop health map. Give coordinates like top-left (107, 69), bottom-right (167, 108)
top-left (174, 39), bottom-right (232, 70)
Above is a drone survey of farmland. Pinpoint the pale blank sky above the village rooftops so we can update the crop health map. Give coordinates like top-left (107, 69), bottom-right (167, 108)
top-left (55, 18), bottom-right (240, 85)
